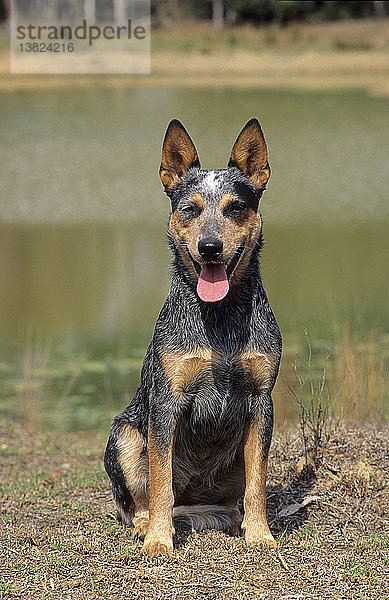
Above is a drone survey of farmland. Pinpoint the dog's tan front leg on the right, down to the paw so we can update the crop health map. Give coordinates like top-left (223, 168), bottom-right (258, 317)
top-left (242, 394), bottom-right (277, 548)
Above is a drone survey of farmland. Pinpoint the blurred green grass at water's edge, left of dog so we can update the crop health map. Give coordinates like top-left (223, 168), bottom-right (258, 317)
top-left (0, 340), bottom-right (144, 431)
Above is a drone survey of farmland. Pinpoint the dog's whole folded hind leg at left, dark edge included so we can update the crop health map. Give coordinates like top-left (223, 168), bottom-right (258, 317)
top-left (105, 424), bottom-right (150, 538)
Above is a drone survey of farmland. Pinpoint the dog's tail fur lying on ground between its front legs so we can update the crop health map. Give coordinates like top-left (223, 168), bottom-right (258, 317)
top-left (173, 504), bottom-right (240, 532)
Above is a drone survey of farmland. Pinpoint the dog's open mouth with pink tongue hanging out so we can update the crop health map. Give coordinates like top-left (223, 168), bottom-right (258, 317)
top-left (193, 244), bottom-right (244, 302)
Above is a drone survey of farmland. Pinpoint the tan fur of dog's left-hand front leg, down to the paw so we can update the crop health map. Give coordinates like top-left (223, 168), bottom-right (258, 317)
top-left (142, 431), bottom-right (174, 556)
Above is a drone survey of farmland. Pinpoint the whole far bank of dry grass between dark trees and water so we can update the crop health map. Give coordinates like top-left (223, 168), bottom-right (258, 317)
top-left (0, 18), bottom-right (389, 98)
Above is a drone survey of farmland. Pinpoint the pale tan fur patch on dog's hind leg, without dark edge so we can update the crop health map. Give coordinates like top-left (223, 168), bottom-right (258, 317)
top-left (118, 425), bottom-right (150, 535)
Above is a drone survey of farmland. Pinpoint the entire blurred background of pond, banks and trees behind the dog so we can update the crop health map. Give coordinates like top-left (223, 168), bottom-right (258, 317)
top-left (0, 0), bottom-right (389, 431)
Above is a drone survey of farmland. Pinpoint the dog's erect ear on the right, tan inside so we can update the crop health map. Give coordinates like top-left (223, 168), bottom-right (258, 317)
top-left (228, 119), bottom-right (270, 189)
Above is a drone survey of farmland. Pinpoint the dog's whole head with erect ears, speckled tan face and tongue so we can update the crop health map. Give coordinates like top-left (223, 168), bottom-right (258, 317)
top-left (159, 119), bottom-right (270, 302)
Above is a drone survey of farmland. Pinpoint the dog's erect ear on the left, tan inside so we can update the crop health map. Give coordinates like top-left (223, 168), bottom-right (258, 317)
top-left (159, 119), bottom-right (200, 190)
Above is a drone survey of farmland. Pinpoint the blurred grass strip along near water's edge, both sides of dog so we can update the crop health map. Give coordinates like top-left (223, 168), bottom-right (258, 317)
top-left (0, 328), bottom-right (389, 432)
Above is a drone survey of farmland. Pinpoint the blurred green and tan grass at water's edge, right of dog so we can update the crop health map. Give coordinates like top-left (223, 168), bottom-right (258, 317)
top-left (274, 324), bottom-right (389, 426)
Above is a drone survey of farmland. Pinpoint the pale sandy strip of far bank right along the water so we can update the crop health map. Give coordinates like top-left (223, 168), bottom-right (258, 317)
top-left (0, 51), bottom-right (389, 97)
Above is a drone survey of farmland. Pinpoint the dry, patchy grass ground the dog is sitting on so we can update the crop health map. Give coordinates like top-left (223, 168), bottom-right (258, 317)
top-left (0, 425), bottom-right (389, 600)
